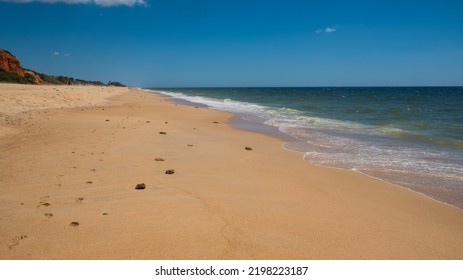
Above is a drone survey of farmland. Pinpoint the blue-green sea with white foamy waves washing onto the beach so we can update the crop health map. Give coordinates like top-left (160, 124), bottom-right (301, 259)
top-left (150, 87), bottom-right (463, 208)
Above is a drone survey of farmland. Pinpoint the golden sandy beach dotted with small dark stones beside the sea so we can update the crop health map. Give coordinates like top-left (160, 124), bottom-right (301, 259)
top-left (0, 84), bottom-right (463, 259)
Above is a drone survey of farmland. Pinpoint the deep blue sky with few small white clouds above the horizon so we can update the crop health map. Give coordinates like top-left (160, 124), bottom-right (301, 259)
top-left (0, 0), bottom-right (463, 87)
